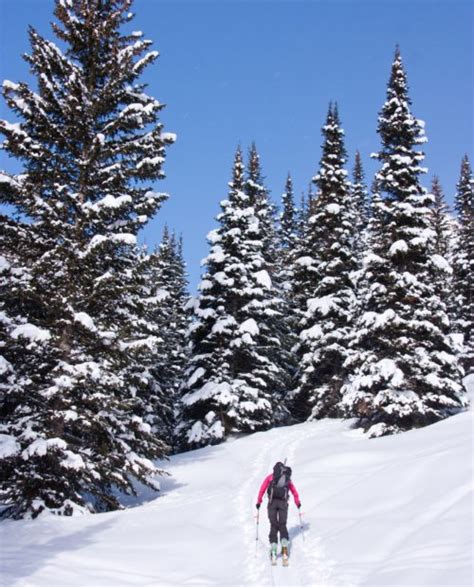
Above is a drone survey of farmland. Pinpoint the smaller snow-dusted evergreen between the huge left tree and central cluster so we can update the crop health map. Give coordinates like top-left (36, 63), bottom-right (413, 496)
top-left (122, 228), bottom-right (189, 446)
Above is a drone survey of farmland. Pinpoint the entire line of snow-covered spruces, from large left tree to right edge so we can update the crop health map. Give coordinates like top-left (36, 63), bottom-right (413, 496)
top-left (0, 0), bottom-right (468, 518)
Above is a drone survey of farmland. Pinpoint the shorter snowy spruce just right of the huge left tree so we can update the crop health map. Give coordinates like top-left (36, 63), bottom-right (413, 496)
top-left (120, 235), bottom-right (186, 443)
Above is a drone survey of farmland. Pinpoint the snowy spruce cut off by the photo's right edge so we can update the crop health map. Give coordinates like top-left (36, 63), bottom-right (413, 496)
top-left (453, 155), bottom-right (474, 373)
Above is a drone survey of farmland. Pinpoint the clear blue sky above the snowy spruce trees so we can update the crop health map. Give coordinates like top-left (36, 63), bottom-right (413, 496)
top-left (0, 0), bottom-right (473, 289)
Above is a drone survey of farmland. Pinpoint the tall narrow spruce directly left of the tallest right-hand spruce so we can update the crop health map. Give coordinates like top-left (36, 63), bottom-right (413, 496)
top-left (294, 106), bottom-right (357, 419)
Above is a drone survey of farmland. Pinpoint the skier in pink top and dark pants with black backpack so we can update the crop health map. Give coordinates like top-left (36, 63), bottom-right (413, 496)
top-left (256, 462), bottom-right (301, 566)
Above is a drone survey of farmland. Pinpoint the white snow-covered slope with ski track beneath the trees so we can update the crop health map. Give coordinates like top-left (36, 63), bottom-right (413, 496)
top-left (0, 404), bottom-right (473, 587)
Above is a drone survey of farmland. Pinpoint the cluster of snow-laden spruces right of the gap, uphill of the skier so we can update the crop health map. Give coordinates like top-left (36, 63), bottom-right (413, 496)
top-left (178, 71), bottom-right (474, 447)
